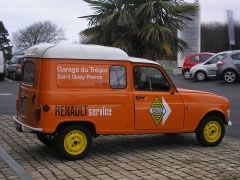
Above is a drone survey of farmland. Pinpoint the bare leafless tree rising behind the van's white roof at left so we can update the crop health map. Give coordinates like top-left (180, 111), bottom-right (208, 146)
top-left (13, 21), bottom-right (66, 51)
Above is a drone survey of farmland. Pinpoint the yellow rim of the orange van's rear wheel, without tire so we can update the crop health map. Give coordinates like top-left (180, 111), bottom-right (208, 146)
top-left (64, 130), bottom-right (87, 155)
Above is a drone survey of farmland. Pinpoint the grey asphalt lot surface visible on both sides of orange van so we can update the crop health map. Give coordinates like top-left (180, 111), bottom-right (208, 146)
top-left (0, 76), bottom-right (240, 139)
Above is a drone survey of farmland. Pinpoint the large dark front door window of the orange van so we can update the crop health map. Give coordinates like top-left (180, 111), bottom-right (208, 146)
top-left (133, 66), bottom-right (170, 91)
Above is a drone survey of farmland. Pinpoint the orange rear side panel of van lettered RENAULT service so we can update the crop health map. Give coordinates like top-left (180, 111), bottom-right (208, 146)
top-left (30, 59), bottom-right (134, 133)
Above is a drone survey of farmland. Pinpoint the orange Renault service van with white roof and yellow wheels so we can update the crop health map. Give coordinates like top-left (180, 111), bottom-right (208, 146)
top-left (14, 44), bottom-right (231, 159)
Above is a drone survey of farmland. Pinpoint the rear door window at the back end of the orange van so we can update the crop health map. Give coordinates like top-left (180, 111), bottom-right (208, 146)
top-left (23, 61), bottom-right (35, 85)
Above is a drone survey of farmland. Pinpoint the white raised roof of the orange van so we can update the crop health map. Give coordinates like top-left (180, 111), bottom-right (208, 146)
top-left (25, 44), bottom-right (158, 64)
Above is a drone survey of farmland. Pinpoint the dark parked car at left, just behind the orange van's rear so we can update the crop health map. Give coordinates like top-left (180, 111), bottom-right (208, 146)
top-left (6, 55), bottom-right (23, 80)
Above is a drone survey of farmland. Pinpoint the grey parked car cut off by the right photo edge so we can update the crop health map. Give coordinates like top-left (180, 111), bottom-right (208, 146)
top-left (217, 50), bottom-right (240, 83)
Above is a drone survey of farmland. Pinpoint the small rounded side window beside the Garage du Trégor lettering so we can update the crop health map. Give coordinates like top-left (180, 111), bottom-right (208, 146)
top-left (110, 66), bottom-right (127, 89)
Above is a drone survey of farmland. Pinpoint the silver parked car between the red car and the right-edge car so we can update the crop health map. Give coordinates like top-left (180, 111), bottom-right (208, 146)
top-left (189, 51), bottom-right (232, 81)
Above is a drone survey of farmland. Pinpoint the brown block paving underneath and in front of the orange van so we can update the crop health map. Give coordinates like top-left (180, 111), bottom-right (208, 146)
top-left (0, 115), bottom-right (240, 180)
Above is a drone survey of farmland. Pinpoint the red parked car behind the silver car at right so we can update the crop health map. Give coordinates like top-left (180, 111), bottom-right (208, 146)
top-left (182, 52), bottom-right (214, 79)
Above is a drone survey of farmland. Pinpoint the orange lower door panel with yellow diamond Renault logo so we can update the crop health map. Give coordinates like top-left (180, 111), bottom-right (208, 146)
top-left (133, 91), bottom-right (185, 130)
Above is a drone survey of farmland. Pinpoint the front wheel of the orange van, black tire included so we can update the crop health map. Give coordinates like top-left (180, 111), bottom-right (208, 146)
top-left (196, 115), bottom-right (225, 147)
